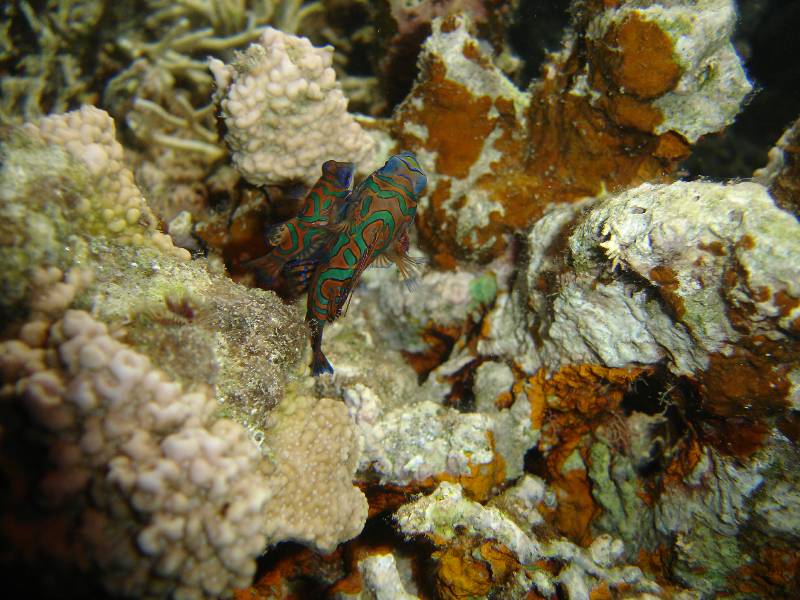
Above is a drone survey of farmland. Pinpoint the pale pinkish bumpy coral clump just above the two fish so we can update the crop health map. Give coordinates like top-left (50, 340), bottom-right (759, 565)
top-left (209, 28), bottom-right (375, 185)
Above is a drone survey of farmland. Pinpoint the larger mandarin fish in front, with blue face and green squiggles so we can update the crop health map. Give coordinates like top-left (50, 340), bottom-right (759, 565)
top-left (306, 152), bottom-right (427, 376)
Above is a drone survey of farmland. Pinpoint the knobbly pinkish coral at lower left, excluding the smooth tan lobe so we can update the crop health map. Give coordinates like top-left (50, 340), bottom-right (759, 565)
top-left (0, 311), bottom-right (274, 597)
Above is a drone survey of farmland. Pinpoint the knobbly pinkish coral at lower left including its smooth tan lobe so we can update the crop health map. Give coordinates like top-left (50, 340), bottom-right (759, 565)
top-left (0, 310), bottom-right (367, 598)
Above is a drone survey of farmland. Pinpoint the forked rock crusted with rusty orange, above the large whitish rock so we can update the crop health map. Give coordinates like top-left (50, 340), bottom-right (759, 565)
top-left (393, 0), bottom-right (751, 267)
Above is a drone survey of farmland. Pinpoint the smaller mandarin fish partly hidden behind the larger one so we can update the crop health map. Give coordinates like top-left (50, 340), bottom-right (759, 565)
top-left (243, 160), bottom-right (355, 293)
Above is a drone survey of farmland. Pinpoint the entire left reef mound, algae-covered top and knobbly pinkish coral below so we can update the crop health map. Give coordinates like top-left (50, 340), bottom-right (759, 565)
top-left (0, 107), bottom-right (366, 597)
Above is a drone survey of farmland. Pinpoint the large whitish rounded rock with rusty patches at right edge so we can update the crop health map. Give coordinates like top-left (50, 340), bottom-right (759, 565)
top-left (482, 181), bottom-right (800, 374)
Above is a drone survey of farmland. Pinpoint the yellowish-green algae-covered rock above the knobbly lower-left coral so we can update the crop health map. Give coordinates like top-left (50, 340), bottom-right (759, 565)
top-left (0, 107), bottom-right (306, 431)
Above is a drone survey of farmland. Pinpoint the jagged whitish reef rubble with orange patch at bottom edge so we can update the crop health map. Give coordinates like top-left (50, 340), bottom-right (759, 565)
top-left (396, 476), bottom-right (660, 598)
